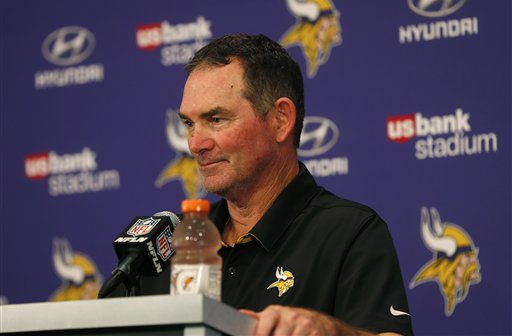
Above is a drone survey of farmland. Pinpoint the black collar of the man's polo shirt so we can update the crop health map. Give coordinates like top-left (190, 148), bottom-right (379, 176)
top-left (210, 162), bottom-right (317, 251)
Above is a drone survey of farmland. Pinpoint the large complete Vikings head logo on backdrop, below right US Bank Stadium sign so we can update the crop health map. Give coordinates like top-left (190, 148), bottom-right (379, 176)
top-left (409, 207), bottom-right (481, 316)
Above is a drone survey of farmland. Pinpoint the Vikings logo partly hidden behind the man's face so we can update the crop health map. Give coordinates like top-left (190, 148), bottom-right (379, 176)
top-left (155, 110), bottom-right (205, 199)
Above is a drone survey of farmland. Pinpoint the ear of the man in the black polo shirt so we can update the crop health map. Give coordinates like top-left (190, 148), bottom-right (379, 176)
top-left (270, 97), bottom-right (297, 143)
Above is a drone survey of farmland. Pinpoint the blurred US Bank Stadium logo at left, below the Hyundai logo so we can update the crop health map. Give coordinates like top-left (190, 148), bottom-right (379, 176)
top-left (25, 147), bottom-right (121, 196)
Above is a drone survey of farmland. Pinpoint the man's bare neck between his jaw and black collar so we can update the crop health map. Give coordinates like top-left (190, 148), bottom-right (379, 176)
top-left (222, 158), bottom-right (299, 245)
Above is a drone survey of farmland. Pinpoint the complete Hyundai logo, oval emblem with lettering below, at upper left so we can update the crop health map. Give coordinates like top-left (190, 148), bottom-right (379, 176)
top-left (34, 26), bottom-right (104, 90)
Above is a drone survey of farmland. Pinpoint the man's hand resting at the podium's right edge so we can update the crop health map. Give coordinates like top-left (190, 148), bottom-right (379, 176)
top-left (240, 305), bottom-right (374, 336)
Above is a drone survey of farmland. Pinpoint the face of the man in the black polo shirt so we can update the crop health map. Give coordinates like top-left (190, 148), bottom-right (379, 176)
top-left (180, 60), bottom-right (276, 197)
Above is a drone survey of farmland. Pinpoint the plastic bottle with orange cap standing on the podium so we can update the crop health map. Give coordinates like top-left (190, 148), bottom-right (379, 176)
top-left (171, 199), bottom-right (222, 301)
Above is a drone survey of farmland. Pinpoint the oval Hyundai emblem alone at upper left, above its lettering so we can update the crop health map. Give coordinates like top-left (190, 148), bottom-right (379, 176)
top-left (42, 26), bottom-right (96, 66)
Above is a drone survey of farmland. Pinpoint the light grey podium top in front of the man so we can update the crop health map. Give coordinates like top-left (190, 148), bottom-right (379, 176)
top-left (0, 295), bottom-right (256, 336)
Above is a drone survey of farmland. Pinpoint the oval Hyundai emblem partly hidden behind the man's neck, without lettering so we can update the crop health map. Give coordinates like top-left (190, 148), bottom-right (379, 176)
top-left (297, 117), bottom-right (340, 157)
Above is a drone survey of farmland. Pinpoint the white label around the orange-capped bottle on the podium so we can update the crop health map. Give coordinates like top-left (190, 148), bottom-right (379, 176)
top-left (171, 264), bottom-right (222, 301)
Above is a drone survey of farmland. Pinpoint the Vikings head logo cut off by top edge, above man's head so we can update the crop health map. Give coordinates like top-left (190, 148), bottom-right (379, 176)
top-left (279, 0), bottom-right (341, 78)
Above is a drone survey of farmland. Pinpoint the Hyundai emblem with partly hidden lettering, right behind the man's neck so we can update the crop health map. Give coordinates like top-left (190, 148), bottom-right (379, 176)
top-left (297, 116), bottom-right (348, 177)
